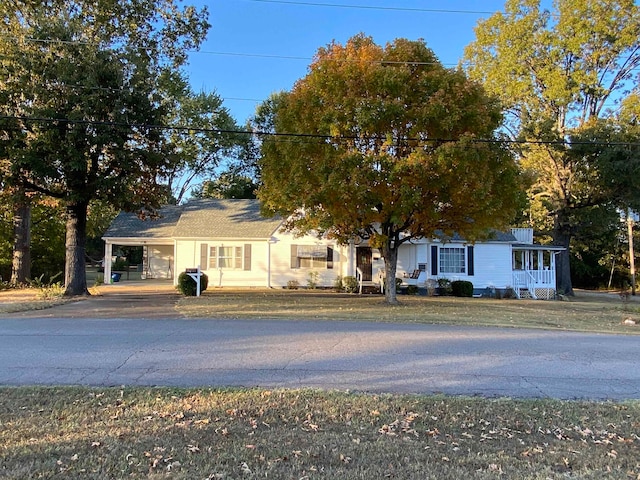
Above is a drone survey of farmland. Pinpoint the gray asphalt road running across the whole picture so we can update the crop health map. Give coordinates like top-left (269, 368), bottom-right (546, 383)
top-left (0, 310), bottom-right (640, 400)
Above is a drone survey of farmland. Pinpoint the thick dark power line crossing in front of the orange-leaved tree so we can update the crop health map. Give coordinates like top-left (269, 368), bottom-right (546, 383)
top-left (0, 115), bottom-right (640, 147)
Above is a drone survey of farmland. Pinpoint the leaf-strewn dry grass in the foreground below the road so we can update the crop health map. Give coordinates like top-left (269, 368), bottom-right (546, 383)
top-left (0, 388), bottom-right (640, 479)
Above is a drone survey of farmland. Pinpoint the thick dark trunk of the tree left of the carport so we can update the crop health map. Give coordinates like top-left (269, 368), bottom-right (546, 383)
top-left (64, 202), bottom-right (89, 296)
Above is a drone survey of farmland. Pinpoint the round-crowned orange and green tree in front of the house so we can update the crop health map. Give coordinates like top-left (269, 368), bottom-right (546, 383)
top-left (258, 35), bottom-right (518, 304)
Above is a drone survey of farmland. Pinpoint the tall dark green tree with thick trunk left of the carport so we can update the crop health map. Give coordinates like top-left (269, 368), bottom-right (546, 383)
top-left (0, 0), bottom-right (209, 295)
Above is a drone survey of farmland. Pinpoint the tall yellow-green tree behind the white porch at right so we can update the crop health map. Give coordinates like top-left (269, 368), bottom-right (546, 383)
top-left (465, 0), bottom-right (640, 294)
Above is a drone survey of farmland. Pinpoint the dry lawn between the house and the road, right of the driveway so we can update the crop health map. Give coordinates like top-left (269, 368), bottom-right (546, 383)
top-left (178, 290), bottom-right (640, 334)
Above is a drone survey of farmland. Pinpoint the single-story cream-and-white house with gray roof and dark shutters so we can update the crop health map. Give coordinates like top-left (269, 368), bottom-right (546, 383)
top-left (103, 199), bottom-right (559, 298)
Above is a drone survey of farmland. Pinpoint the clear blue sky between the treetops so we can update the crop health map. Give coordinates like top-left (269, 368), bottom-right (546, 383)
top-left (187, 0), bottom-right (504, 125)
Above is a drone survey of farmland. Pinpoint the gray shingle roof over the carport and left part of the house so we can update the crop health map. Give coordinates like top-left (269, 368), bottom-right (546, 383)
top-left (104, 199), bottom-right (282, 239)
